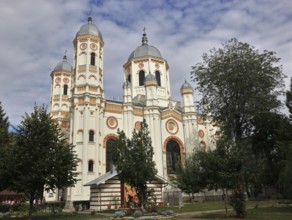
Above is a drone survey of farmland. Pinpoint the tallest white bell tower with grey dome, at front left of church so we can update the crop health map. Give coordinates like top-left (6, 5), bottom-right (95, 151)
top-left (67, 17), bottom-right (104, 204)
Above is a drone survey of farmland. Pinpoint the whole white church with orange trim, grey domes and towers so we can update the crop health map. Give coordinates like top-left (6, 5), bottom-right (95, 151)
top-left (46, 18), bottom-right (218, 208)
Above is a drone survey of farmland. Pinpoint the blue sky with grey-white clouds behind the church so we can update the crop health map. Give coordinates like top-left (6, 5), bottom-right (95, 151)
top-left (0, 0), bottom-right (292, 125)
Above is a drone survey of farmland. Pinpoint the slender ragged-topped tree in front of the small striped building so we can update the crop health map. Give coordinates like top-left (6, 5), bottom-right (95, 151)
top-left (112, 120), bottom-right (157, 205)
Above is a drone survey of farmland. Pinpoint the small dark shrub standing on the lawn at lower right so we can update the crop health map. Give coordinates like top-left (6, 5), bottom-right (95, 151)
top-left (230, 189), bottom-right (246, 218)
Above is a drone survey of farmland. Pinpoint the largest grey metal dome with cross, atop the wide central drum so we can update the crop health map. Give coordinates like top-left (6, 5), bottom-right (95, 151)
top-left (128, 32), bottom-right (163, 61)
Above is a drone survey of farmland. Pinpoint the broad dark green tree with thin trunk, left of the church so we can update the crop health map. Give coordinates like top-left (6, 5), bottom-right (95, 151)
top-left (2, 106), bottom-right (77, 218)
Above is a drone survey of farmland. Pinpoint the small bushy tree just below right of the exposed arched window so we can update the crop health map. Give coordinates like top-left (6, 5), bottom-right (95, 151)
top-left (172, 152), bottom-right (207, 199)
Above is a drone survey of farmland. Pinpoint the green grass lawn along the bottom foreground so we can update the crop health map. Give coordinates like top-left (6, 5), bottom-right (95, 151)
top-left (0, 200), bottom-right (292, 220)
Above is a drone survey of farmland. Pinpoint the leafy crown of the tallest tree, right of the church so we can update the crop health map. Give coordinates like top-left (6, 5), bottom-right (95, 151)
top-left (191, 38), bottom-right (284, 140)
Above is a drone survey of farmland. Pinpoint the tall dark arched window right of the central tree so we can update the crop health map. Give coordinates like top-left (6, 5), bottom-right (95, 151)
top-left (166, 140), bottom-right (181, 174)
